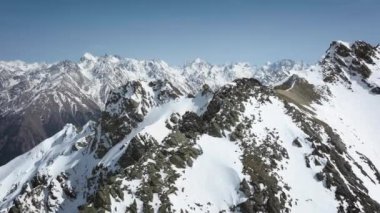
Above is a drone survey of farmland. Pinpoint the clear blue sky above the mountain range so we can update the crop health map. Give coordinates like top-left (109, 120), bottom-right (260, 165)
top-left (0, 0), bottom-right (380, 65)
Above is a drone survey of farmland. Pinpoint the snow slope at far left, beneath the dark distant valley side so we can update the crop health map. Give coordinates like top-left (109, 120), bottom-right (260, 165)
top-left (0, 122), bottom-right (95, 212)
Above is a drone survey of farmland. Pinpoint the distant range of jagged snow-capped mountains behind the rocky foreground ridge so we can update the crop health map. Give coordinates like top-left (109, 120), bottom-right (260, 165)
top-left (0, 53), bottom-right (296, 165)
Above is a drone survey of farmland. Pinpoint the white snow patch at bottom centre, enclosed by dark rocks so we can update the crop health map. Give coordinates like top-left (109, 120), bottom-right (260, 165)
top-left (169, 135), bottom-right (246, 212)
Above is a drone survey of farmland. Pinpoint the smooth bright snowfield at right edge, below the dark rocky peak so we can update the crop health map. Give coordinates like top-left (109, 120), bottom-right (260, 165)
top-left (315, 81), bottom-right (380, 202)
